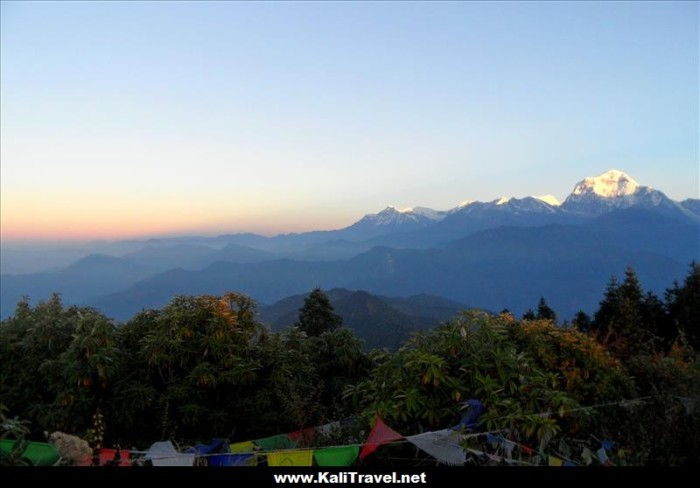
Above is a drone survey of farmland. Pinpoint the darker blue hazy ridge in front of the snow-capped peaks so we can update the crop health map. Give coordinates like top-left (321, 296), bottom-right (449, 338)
top-left (85, 208), bottom-right (700, 318)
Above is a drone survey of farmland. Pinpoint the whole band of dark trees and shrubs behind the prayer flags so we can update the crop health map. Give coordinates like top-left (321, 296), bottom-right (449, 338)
top-left (0, 264), bottom-right (700, 465)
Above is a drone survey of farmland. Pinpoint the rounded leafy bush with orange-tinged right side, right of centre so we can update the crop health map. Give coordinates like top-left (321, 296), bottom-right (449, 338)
top-left (346, 311), bottom-right (633, 450)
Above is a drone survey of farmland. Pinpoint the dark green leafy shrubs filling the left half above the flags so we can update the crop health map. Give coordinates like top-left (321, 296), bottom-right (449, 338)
top-left (0, 293), bottom-right (369, 446)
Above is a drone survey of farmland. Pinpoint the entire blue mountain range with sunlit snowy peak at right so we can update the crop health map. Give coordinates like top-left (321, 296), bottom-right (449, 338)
top-left (0, 170), bottom-right (700, 320)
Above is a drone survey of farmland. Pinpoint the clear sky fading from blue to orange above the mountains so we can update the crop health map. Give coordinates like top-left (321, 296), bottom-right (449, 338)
top-left (0, 1), bottom-right (700, 243)
